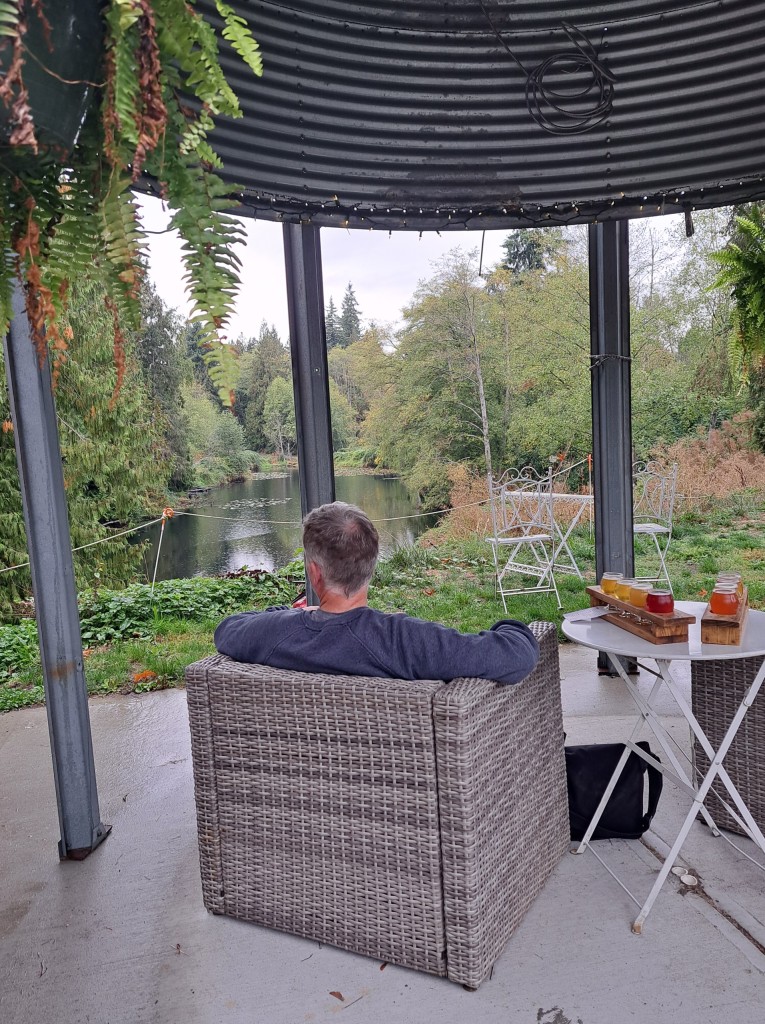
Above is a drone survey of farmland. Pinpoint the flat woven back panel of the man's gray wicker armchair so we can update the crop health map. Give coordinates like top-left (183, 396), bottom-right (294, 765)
top-left (186, 656), bottom-right (447, 975)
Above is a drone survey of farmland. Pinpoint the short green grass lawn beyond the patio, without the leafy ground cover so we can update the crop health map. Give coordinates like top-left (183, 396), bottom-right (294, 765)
top-left (0, 509), bottom-right (765, 712)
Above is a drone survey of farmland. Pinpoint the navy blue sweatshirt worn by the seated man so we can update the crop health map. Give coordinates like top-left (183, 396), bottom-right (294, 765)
top-left (215, 607), bottom-right (539, 683)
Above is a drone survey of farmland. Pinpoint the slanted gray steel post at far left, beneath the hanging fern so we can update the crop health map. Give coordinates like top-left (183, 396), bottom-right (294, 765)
top-left (5, 286), bottom-right (109, 860)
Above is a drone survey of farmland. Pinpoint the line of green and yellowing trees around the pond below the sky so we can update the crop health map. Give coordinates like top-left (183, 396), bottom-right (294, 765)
top-left (0, 201), bottom-right (765, 613)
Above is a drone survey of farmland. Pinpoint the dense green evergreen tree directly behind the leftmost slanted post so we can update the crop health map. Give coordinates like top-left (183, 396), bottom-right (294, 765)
top-left (0, 283), bottom-right (168, 616)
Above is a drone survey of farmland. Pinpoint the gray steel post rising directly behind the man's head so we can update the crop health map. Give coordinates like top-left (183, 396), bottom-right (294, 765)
top-left (284, 224), bottom-right (335, 604)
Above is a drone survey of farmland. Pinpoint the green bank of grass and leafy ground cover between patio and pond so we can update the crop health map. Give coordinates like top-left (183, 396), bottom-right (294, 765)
top-left (0, 508), bottom-right (765, 711)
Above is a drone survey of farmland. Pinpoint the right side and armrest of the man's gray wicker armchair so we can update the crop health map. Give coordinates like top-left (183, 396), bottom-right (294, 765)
top-left (433, 623), bottom-right (569, 986)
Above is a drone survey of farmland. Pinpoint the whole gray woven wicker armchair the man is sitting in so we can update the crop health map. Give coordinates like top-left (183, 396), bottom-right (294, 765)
top-left (186, 623), bottom-right (568, 987)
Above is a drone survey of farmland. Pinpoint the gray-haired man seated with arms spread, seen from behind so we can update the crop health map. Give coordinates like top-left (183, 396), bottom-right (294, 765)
top-left (215, 502), bottom-right (539, 683)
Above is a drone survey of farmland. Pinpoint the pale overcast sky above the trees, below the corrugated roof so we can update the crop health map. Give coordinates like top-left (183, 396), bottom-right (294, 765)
top-left (141, 198), bottom-right (508, 341)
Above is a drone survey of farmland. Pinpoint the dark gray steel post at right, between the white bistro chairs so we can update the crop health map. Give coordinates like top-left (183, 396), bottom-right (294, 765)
top-left (589, 220), bottom-right (635, 673)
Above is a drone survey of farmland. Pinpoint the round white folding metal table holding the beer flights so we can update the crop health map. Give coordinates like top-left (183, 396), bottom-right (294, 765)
top-left (562, 601), bottom-right (765, 934)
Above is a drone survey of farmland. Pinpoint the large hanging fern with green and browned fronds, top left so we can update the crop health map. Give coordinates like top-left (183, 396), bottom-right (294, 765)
top-left (0, 0), bottom-right (262, 403)
